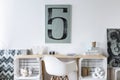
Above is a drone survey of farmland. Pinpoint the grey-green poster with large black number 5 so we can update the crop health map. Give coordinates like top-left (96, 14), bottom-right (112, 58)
top-left (45, 5), bottom-right (71, 43)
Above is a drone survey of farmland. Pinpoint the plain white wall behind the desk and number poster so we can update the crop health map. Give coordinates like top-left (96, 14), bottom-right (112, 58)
top-left (0, 0), bottom-right (120, 54)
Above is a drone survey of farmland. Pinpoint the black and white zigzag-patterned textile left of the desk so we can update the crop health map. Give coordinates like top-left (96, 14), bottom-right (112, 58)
top-left (0, 50), bottom-right (26, 80)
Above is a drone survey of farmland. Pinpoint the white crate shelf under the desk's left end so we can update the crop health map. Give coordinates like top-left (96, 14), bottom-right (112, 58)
top-left (14, 57), bottom-right (42, 80)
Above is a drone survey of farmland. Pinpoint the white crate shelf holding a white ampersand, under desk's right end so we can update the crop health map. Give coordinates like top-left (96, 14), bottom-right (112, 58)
top-left (79, 55), bottom-right (107, 80)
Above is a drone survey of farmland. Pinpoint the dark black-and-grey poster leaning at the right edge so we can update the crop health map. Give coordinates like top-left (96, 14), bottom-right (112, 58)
top-left (107, 29), bottom-right (120, 67)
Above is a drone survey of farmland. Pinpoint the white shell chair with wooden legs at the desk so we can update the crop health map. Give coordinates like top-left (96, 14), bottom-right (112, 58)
top-left (42, 55), bottom-right (77, 80)
